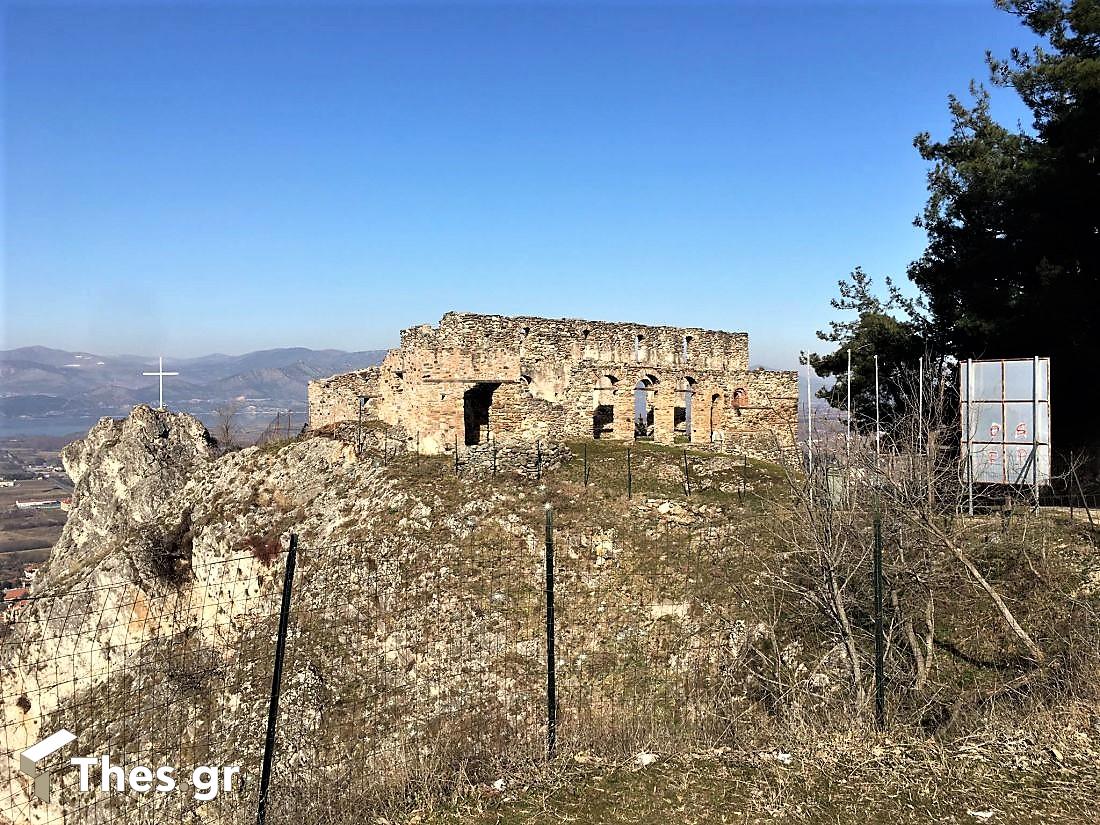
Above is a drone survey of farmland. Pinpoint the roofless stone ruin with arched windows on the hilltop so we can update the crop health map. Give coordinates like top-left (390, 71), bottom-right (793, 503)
top-left (309, 312), bottom-right (799, 458)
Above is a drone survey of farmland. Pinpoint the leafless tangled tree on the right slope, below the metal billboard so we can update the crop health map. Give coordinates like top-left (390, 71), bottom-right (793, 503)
top-left (766, 365), bottom-right (1073, 726)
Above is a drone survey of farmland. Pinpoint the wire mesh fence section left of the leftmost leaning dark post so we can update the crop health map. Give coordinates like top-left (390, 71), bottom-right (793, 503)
top-left (0, 554), bottom-right (275, 823)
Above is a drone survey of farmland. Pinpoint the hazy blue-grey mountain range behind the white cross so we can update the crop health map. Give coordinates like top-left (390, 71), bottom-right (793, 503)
top-left (0, 347), bottom-right (385, 419)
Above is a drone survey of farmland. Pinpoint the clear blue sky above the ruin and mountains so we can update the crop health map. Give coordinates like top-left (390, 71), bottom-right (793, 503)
top-left (2, 0), bottom-right (1031, 366)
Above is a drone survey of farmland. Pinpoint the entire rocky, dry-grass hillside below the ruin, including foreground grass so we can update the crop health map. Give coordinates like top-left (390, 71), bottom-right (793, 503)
top-left (0, 407), bottom-right (1100, 823)
